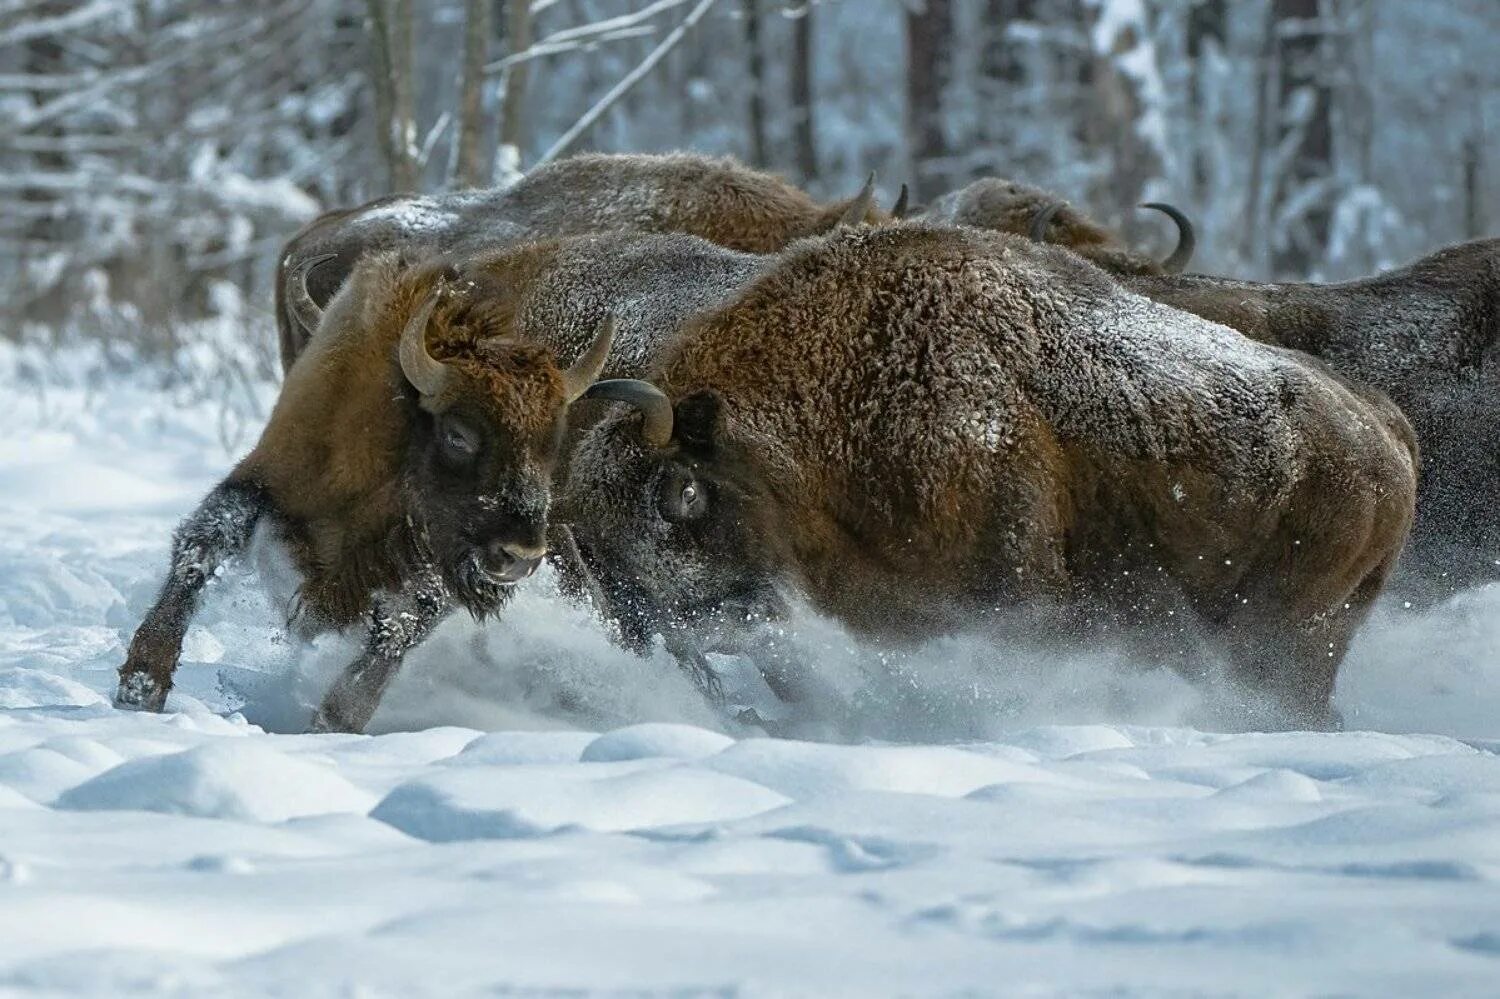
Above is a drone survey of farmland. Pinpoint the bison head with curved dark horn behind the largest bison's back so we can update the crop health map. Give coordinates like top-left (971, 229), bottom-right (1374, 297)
top-left (911, 177), bottom-right (1197, 275)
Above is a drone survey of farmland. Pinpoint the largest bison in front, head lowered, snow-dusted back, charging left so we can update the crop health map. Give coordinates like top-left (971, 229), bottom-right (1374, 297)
top-left (554, 224), bottom-right (1416, 725)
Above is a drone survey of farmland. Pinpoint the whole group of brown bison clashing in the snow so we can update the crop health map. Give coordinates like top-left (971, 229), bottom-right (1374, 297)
top-left (116, 155), bottom-right (1500, 731)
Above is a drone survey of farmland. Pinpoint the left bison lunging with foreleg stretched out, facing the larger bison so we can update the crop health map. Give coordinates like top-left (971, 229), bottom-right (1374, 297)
top-left (116, 234), bottom-right (764, 731)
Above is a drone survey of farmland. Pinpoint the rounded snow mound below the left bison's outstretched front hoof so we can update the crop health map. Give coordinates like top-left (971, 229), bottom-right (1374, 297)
top-left (57, 741), bottom-right (374, 822)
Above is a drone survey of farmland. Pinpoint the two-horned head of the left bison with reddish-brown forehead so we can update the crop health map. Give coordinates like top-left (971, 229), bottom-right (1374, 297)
top-left (293, 255), bottom-right (615, 615)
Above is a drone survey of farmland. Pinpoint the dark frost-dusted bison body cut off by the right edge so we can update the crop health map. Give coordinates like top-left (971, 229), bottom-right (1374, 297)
top-left (1127, 239), bottom-right (1500, 594)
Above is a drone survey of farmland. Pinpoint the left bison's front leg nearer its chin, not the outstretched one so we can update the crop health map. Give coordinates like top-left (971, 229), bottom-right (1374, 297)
top-left (312, 569), bottom-right (453, 732)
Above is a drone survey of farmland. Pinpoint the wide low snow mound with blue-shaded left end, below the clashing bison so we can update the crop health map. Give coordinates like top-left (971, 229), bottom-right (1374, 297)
top-left (371, 764), bottom-right (788, 842)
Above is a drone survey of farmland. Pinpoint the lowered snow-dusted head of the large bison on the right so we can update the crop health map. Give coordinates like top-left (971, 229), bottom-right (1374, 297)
top-left (558, 380), bottom-right (785, 647)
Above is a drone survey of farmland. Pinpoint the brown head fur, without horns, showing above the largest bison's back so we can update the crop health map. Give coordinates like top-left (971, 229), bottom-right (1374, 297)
top-left (915, 177), bottom-right (1188, 275)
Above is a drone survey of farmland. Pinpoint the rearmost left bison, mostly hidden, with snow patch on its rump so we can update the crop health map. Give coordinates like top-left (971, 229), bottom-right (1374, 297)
top-left (276, 153), bottom-right (885, 371)
